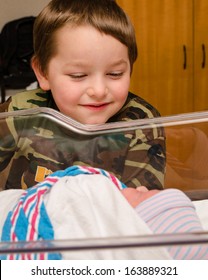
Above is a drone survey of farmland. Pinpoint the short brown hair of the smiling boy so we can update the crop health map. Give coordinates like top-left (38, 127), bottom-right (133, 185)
top-left (33, 0), bottom-right (137, 73)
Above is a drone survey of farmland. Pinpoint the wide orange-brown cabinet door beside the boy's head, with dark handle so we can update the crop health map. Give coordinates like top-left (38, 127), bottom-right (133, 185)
top-left (117, 0), bottom-right (193, 115)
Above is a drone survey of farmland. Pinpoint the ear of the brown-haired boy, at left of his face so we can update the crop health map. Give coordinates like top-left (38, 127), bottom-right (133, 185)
top-left (31, 57), bottom-right (50, 90)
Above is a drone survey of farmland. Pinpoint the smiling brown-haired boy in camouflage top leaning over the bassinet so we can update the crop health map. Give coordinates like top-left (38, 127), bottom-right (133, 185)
top-left (0, 0), bottom-right (165, 189)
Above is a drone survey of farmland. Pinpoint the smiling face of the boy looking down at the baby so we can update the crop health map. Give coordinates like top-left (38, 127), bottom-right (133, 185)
top-left (34, 25), bottom-right (130, 124)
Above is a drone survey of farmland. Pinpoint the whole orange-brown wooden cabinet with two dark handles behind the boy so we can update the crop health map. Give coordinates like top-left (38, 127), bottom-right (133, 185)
top-left (117, 0), bottom-right (208, 115)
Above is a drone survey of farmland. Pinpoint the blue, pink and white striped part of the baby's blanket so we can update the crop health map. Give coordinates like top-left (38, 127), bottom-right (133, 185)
top-left (1, 166), bottom-right (126, 260)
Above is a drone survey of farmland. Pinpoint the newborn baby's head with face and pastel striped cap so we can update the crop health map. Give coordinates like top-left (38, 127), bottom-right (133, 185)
top-left (121, 186), bottom-right (208, 260)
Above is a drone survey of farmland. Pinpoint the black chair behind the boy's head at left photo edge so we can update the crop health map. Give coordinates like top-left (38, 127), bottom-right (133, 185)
top-left (0, 16), bottom-right (36, 102)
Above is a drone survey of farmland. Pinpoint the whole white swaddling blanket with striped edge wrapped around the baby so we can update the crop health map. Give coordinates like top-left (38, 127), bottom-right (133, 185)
top-left (1, 166), bottom-right (170, 259)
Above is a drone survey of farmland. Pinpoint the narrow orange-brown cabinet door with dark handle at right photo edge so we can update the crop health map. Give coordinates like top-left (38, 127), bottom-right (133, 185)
top-left (194, 0), bottom-right (208, 111)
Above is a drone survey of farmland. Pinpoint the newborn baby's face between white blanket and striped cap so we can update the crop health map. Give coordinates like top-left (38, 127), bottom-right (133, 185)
top-left (121, 186), bottom-right (160, 208)
